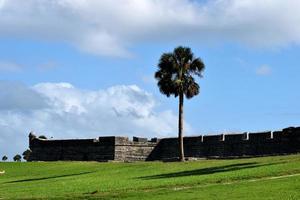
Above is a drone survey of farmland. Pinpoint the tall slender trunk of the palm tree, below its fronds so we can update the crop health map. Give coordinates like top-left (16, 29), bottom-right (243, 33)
top-left (178, 93), bottom-right (184, 161)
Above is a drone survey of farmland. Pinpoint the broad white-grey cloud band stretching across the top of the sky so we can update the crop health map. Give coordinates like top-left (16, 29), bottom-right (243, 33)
top-left (0, 0), bottom-right (300, 56)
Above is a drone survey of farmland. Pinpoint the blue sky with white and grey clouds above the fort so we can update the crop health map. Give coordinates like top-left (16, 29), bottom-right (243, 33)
top-left (0, 0), bottom-right (300, 158)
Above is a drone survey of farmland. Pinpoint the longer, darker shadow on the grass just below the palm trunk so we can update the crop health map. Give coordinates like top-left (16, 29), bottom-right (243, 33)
top-left (138, 162), bottom-right (280, 180)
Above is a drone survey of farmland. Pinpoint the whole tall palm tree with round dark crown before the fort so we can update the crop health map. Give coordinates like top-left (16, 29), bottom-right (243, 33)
top-left (155, 46), bottom-right (205, 161)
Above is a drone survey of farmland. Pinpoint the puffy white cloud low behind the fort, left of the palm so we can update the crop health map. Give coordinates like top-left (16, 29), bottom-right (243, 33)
top-left (0, 82), bottom-right (191, 159)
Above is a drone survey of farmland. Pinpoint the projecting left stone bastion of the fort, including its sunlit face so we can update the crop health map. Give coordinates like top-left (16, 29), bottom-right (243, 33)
top-left (28, 134), bottom-right (157, 161)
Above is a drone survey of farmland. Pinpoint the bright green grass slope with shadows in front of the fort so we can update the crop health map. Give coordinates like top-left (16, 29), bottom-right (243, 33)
top-left (0, 155), bottom-right (300, 200)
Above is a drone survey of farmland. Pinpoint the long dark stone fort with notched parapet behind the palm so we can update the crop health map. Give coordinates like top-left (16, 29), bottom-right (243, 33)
top-left (28, 127), bottom-right (300, 161)
